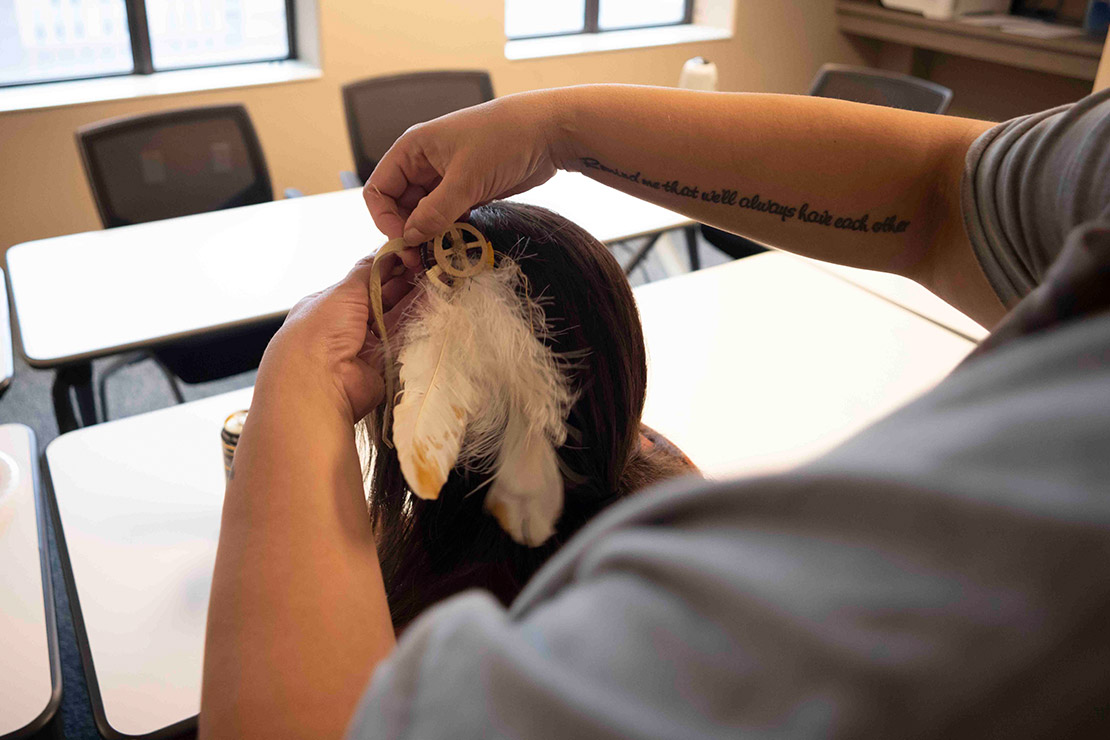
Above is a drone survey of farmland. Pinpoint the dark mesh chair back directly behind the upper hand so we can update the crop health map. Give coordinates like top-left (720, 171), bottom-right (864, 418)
top-left (343, 72), bottom-right (493, 182)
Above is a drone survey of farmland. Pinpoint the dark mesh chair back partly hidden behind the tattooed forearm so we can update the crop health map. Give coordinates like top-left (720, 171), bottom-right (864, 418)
top-left (809, 64), bottom-right (952, 113)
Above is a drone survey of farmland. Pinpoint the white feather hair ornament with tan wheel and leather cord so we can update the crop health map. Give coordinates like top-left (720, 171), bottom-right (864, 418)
top-left (370, 223), bottom-right (574, 547)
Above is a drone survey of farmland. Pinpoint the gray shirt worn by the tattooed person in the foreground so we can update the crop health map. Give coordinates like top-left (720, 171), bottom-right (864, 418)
top-left (350, 94), bottom-right (1110, 739)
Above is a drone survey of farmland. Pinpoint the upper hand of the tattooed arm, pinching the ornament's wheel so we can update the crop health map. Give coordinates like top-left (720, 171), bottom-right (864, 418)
top-left (363, 91), bottom-right (557, 246)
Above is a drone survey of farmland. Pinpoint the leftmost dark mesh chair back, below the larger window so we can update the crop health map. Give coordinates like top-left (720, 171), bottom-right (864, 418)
top-left (77, 105), bottom-right (273, 227)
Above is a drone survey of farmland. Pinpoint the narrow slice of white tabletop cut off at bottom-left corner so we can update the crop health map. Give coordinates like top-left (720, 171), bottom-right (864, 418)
top-left (0, 424), bottom-right (62, 737)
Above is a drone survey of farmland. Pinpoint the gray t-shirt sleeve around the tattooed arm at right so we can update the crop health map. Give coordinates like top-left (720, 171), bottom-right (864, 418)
top-left (961, 89), bottom-right (1110, 307)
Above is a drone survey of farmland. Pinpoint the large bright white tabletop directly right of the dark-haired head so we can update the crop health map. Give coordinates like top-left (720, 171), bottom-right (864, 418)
top-left (636, 252), bottom-right (975, 477)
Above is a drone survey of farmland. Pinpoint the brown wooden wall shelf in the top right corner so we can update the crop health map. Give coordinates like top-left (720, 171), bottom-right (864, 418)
top-left (836, 0), bottom-right (1102, 80)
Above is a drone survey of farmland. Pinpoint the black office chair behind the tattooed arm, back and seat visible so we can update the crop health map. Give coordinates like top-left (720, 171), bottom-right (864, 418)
top-left (702, 64), bottom-right (952, 260)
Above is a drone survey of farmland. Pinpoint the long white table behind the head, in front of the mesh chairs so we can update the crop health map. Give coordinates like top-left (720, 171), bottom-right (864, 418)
top-left (8, 172), bottom-right (692, 367)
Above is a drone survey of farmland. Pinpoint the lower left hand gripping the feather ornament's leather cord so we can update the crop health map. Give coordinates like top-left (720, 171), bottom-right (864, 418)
top-left (258, 251), bottom-right (415, 423)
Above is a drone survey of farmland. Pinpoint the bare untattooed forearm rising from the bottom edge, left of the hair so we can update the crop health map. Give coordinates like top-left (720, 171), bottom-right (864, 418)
top-left (200, 366), bottom-right (394, 738)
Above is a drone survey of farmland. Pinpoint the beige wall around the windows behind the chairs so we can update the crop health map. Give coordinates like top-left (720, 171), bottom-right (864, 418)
top-left (0, 0), bottom-right (860, 249)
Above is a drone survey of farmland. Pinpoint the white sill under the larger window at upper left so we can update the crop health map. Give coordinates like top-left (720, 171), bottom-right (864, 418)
top-left (0, 60), bottom-right (321, 113)
